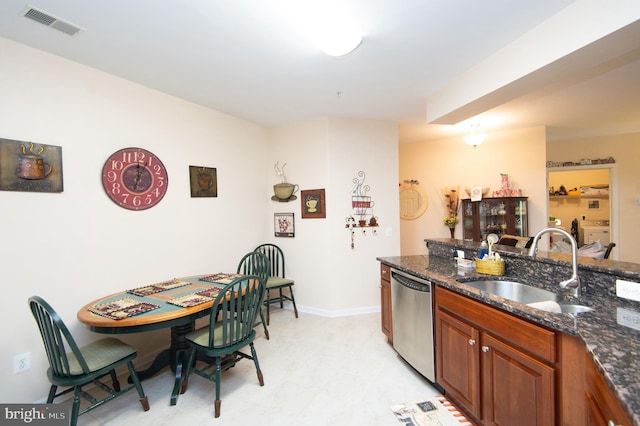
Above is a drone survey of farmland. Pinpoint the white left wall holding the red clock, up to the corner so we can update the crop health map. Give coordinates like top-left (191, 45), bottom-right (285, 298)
top-left (0, 39), bottom-right (270, 402)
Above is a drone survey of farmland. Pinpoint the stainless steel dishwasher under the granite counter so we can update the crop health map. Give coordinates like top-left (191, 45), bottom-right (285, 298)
top-left (391, 268), bottom-right (436, 382)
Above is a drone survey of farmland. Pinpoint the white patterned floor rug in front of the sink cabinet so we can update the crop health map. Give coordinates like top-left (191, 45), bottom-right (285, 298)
top-left (391, 396), bottom-right (473, 426)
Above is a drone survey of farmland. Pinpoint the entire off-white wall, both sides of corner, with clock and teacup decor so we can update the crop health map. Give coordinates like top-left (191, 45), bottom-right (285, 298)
top-left (0, 38), bottom-right (400, 402)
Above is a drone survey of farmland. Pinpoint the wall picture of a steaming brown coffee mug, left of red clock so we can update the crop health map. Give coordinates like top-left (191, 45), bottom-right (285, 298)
top-left (0, 139), bottom-right (63, 192)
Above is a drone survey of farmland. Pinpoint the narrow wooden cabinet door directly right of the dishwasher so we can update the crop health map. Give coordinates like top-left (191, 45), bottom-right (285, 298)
top-left (436, 310), bottom-right (481, 419)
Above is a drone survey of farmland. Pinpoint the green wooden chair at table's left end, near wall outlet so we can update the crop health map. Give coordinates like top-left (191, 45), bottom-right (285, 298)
top-left (29, 296), bottom-right (149, 426)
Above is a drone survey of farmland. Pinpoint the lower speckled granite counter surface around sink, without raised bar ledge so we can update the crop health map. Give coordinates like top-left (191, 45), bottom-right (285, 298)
top-left (377, 253), bottom-right (640, 425)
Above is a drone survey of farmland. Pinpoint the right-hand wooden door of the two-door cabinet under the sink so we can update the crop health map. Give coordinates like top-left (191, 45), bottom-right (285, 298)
top-left (481, 334), bottom-right (555, 426)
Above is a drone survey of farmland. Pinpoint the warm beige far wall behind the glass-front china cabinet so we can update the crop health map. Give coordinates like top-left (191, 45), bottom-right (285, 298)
top-left (399, 127), bottom-right (547, 255)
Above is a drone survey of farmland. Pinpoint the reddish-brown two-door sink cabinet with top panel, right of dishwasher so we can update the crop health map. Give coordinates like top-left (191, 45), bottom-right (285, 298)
top-left (435, 287), bottom-right (557, 426)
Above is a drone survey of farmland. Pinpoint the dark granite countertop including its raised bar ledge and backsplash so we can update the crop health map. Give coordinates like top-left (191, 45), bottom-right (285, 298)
top-left (377, 239), bottom-right (640, 425)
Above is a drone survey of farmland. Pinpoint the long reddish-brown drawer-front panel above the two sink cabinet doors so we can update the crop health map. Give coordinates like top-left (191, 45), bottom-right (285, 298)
top-left (435, 286), bottom-right (557, 363)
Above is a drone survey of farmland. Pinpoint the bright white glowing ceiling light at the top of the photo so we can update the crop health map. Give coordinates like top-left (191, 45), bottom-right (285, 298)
top-left (280, 0), bottom-right (362, 56)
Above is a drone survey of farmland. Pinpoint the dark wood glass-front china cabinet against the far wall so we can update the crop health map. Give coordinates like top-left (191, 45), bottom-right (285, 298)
top-left (462, 197), bottom-right (529, 241)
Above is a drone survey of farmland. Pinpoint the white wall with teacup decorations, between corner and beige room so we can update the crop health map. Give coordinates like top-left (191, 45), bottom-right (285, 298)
top-left (267, 118), bottom-right (400, 316)
